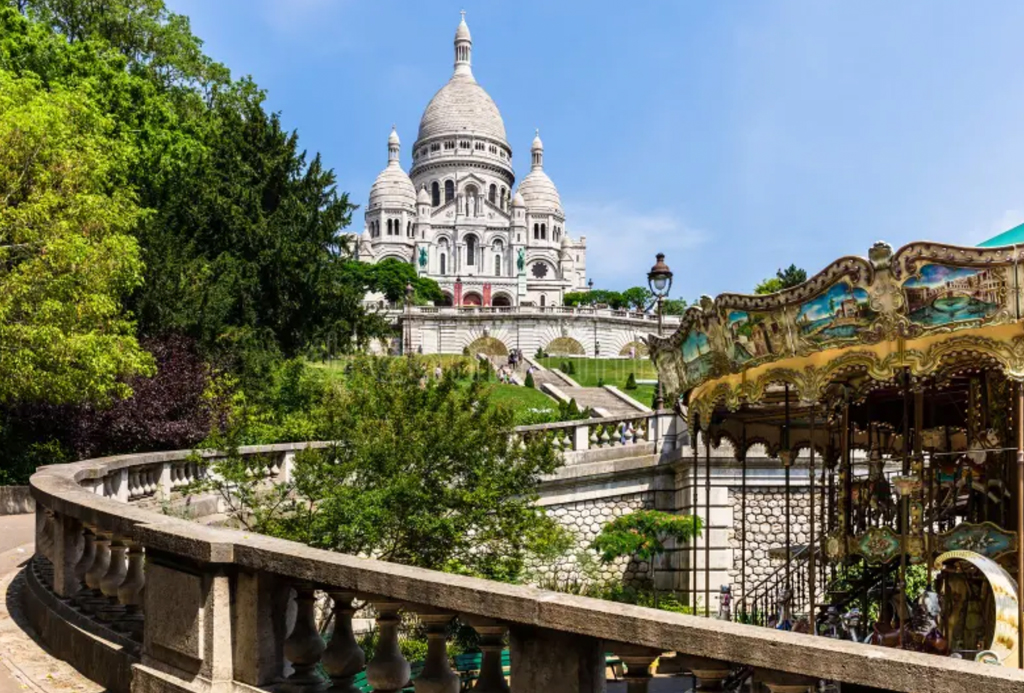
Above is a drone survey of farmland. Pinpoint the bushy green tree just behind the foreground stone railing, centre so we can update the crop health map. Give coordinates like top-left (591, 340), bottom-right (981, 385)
top-left (201, 357), bottom-right (560, 579)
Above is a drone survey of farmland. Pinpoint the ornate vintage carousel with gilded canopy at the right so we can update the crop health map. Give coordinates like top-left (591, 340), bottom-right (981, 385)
top-left (649, 243), bottom-right (1024, 667)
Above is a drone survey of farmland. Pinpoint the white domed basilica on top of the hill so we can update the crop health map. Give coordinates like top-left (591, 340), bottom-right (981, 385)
top-left (356, 16), bottom-right (587, 306)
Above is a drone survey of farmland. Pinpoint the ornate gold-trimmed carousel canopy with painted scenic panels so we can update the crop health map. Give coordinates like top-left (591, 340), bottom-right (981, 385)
top-left (648, 237), bottom-right (1024, 417)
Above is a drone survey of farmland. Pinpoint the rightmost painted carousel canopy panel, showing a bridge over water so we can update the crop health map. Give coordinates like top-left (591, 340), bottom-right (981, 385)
top-left (903, 264), bottom-right (1007, 328)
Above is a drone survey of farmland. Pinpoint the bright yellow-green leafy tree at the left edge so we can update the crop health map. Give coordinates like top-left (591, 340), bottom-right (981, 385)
top-left (0, 71), bottom-right (153, 403)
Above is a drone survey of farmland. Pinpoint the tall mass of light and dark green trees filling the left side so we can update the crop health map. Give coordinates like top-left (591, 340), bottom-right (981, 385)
top-left (0, 0), bottom-right (391, 481)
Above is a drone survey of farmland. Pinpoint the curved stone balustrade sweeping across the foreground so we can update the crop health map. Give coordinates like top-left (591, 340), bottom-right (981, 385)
top-left (27, 444), bottom-right (1024, 693)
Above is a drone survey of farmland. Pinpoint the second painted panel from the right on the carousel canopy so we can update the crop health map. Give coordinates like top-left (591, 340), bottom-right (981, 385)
top-left (797, 281), bottom-right (878, 345)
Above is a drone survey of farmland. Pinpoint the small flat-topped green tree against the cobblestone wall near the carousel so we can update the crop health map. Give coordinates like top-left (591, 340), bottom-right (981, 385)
top-left (591, 510), bottom-right (703, 608)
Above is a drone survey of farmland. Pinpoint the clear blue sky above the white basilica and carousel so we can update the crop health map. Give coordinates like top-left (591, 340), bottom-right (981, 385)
top-left (168, 0), bottom-right (1024, 300)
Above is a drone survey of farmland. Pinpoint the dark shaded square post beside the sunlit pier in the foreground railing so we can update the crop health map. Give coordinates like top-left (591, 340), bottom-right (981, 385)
top-left (232, 571), bottom-right (295, 687)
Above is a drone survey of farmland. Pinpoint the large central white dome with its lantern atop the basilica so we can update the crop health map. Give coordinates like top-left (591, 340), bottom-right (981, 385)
top-left (418, 16), bottom-right (508, 145)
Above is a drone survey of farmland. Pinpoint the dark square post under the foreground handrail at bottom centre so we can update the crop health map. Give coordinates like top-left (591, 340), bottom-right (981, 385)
top-left (510, 625), bottom-right (605, 693)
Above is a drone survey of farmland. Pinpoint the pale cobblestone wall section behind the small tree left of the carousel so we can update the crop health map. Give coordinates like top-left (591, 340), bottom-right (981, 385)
top-left (527, 492), bottom-right (654, 589)
